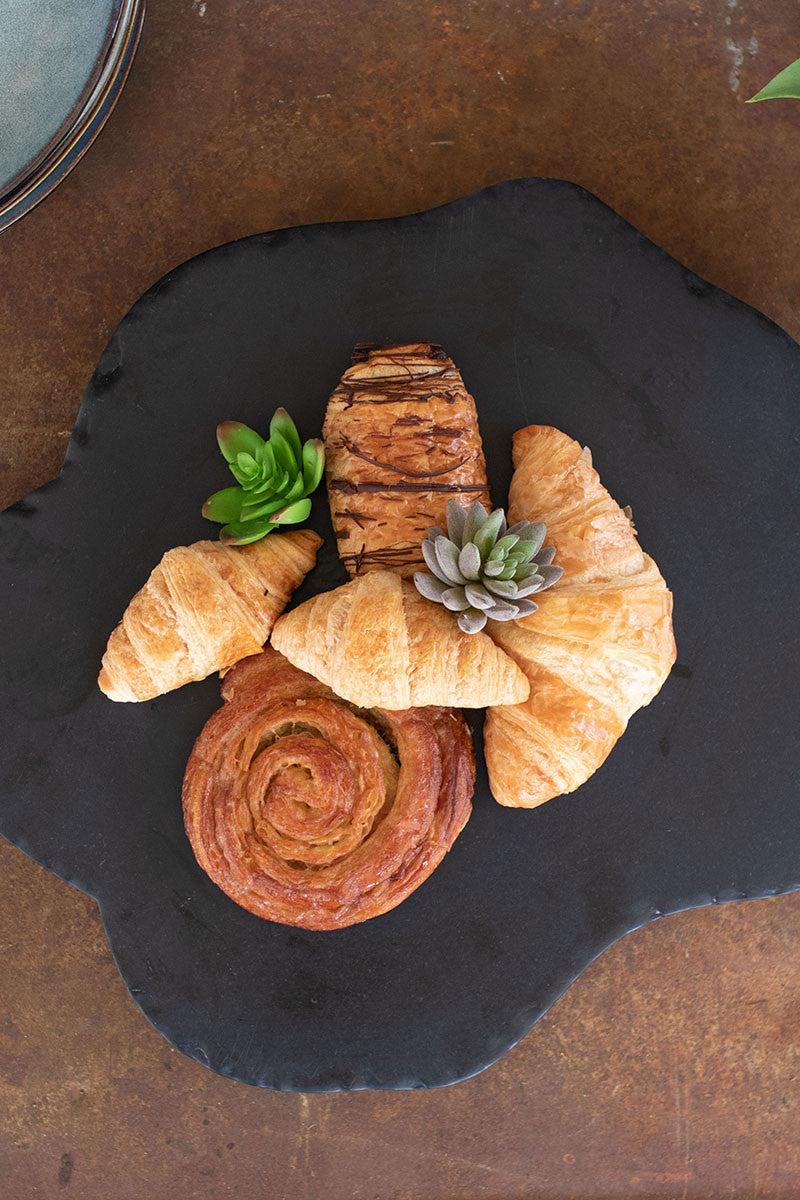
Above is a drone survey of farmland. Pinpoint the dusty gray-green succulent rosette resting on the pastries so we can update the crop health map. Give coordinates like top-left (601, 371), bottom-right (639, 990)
top-left (414, 500), bottom-right (564, 634)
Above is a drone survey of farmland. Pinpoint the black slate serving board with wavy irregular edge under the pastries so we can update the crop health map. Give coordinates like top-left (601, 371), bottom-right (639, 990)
top-left (0, 179), bottom-right (800, 1091)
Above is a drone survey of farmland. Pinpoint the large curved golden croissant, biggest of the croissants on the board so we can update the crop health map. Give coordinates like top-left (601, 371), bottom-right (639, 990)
top-left (483, 425), bottom-right (675, 808)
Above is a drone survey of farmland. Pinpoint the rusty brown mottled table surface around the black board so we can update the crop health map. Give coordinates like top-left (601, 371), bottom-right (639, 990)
top-left (0, 0), bottom-right (800, 1200)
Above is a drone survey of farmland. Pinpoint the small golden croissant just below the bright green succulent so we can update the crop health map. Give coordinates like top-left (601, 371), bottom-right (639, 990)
top-left (97, 529), bottom-right (321, 701)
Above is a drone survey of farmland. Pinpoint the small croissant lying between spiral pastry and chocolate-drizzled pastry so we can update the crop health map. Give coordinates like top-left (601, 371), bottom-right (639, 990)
top-left (272, 571), bottom-right (529, 709)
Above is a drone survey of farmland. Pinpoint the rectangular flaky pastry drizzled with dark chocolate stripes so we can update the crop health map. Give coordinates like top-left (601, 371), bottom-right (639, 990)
top-left (323, 342), bottom-right (489, 576)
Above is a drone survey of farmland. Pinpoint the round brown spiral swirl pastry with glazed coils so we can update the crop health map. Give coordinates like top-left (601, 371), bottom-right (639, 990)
top-left (184, 647), bottom-right (475, 929)
